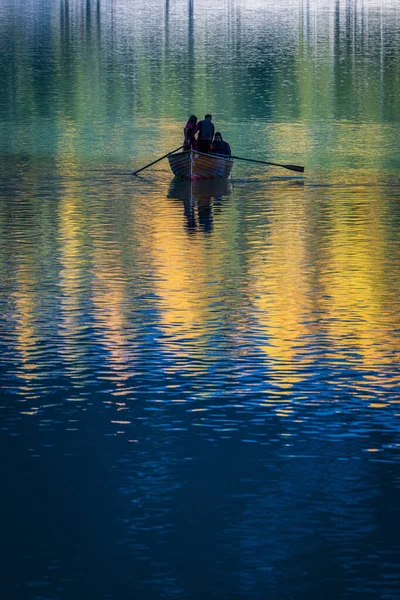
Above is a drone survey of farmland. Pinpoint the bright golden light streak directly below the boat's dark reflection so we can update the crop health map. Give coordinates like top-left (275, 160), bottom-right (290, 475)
top-left (145, 183), bottom-right (242, 370)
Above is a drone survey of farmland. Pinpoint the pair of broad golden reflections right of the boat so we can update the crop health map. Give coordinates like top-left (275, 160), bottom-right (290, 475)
top-left (249, 179), bottom-right (400, 391)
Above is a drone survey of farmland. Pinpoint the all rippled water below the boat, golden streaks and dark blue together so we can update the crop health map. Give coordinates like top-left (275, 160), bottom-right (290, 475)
top-left (0, 159), bottom-right (400, 600)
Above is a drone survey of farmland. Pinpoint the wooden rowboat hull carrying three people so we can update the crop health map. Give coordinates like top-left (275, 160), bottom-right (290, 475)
top-left (168, 150), bottom-right (233, 180)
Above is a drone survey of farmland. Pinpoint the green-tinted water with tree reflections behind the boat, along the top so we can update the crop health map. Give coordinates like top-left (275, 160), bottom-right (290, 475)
top-left (0, 0), bottom-right (400, 178)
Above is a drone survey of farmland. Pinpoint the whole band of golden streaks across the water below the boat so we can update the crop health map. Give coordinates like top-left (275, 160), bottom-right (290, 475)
top-left (3, 166), bottom-right (399, 397)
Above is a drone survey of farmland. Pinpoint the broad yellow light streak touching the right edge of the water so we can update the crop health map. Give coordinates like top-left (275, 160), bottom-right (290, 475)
top-left (320, 187), bottom-right (400, 390)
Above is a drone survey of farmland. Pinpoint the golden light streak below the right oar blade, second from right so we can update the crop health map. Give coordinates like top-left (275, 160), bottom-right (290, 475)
top-left (249, 185), bottom-right (311, 391)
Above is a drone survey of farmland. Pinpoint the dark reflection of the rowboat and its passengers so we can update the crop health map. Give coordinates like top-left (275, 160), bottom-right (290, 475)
top-left (167, 177), bottom-right (233, 233)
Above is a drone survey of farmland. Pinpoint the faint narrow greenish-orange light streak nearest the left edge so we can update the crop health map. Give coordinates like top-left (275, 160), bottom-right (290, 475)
top-left (4, 169), bottom-right (52, 390)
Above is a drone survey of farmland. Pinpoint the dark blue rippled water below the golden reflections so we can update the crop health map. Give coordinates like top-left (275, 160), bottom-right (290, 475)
top-left (1, 338), bottom-right (400, 600)
